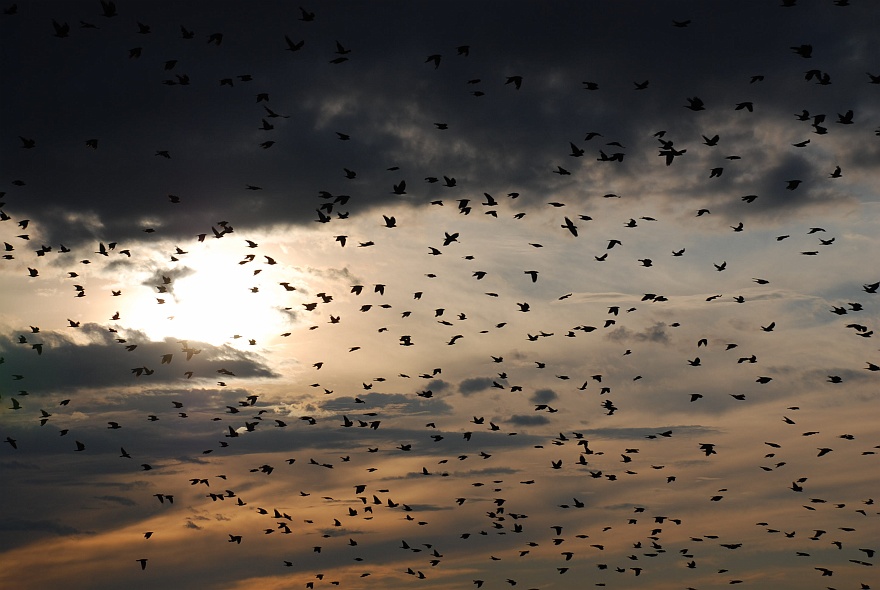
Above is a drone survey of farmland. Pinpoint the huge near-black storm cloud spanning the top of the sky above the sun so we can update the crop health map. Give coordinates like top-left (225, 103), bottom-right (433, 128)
top-left (2, 2), bottom-right (880, 243)
